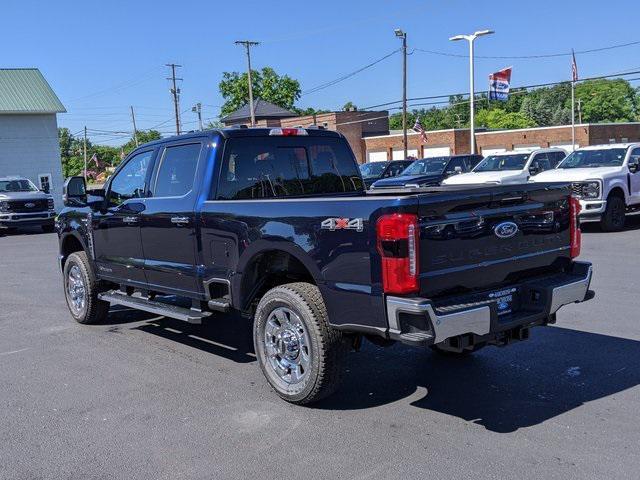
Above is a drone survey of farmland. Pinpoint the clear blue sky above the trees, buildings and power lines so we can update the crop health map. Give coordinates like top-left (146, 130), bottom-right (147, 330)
top-left (0, 0), bottom-right (640, 145)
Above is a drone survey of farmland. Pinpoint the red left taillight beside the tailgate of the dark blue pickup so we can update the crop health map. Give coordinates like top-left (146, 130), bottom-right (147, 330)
top-left (376, 213), bottom-right (420, 293)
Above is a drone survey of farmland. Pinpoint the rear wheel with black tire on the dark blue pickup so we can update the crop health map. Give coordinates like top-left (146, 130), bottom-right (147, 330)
top-left (253, 282), bottom-right (349, 405)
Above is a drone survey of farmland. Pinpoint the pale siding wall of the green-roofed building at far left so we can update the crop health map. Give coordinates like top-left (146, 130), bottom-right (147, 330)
top-left (0, 113), bottom-right (63, 211)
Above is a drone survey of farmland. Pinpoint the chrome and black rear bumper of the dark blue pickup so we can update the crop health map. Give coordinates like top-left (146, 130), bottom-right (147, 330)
top-left (386, 262), bottom-right (594, 345)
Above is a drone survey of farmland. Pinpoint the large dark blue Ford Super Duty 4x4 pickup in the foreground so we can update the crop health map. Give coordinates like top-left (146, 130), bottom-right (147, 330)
top-left (57, 128), bottom-right (593, 404)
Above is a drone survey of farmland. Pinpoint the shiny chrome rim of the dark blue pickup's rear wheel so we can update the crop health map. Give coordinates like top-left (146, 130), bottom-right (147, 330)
top-left (264, 307), bottom-right (311, 385)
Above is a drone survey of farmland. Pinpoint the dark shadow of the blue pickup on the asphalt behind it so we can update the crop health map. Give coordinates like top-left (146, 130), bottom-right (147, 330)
top-left (316, 327), bottom-right (640, 433)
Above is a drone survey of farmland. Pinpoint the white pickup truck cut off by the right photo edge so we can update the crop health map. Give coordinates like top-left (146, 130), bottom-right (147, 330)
top-left (534, 143), bottom-right (640, 231)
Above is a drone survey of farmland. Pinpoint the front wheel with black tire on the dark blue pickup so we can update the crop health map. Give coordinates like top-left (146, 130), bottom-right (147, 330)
top-left (63, 252), bottom-right (109, 324)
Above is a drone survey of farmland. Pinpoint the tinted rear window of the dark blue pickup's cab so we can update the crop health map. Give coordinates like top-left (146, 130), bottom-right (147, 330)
top-left (216, 137), bottom-right (363, 200)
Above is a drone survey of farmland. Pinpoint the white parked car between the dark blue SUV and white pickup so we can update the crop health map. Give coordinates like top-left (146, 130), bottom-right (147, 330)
top-left (442, 148), bottom-right (567, 185)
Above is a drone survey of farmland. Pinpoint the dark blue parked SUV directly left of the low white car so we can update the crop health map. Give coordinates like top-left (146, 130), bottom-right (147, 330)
top-left (372, 155), bottom-right (482, 188)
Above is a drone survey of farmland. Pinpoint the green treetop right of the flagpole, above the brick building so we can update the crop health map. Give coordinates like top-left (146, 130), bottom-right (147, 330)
top-left (569, 79), bottom-right (640, 123)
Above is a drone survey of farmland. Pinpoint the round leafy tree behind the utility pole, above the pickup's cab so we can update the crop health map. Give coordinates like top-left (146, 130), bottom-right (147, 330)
top-left (218, 67), bottom-right (302, 116)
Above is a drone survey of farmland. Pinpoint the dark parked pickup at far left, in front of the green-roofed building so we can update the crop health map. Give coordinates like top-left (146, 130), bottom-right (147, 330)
top-left (0, 176), bottom-right (56, 232)
